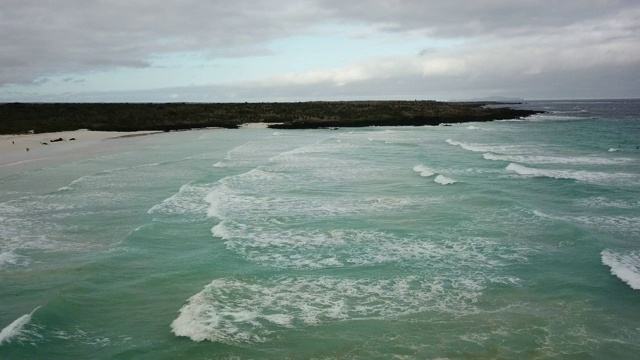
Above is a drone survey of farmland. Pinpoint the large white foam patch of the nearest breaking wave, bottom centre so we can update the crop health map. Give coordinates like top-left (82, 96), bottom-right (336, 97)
top-left (171, 276), bottom-right (484, 344)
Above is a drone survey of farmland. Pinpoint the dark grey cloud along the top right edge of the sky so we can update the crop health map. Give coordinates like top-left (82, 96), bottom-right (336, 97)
top-left (320, 0), bottom-right (640, 37)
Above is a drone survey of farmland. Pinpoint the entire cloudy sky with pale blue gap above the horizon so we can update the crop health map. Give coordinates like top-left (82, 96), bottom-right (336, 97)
top-left (0, 0), bottom-right (640, 102)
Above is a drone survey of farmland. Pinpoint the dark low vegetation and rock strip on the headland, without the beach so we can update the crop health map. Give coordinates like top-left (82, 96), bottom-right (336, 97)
top-left (0, 101), bottom-right (537, 134)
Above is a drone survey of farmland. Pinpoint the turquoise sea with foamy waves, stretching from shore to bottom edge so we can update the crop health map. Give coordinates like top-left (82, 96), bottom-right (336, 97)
top-left (0, 101), bottom-right (640, 359)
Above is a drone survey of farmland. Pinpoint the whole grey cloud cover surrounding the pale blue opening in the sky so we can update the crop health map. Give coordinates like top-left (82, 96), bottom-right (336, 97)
top-left (0, 0), bottom-right (640, 101)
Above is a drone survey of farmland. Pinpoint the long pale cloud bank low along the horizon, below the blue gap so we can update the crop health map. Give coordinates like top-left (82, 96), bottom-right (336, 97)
top-left (6, 63), bottom-right (640, 102)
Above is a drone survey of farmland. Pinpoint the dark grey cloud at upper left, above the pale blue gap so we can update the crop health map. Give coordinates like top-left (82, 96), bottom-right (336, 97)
top-left (0, 0), bottom-right (315, 85)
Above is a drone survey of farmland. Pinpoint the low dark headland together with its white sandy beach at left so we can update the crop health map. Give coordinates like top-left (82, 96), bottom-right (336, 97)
top-left (0, 101), bottom-right (541, 173)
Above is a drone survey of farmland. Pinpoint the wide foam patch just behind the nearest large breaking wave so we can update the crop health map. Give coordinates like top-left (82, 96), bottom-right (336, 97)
top-left (212, 212), bottom-right (530, 270)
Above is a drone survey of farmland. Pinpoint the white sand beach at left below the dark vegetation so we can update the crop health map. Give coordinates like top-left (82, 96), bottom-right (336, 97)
top-left (0, 130), bottom-right (158, 169)
